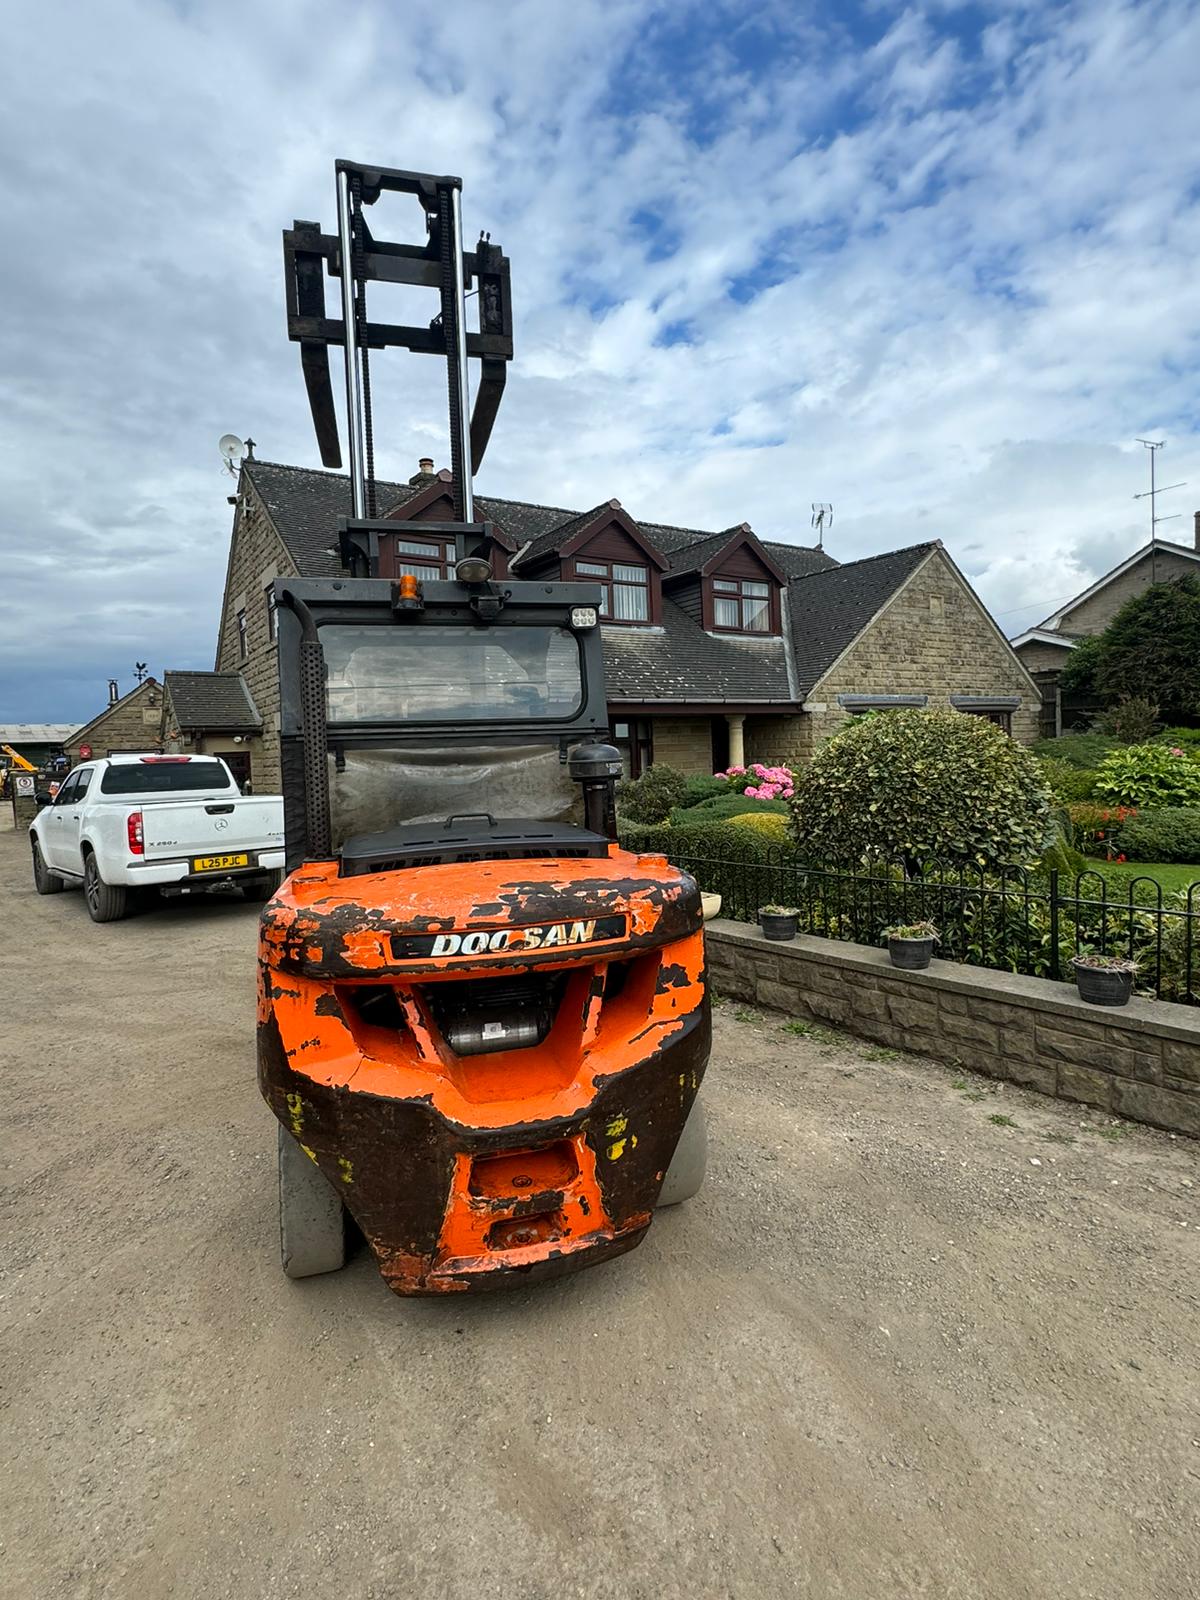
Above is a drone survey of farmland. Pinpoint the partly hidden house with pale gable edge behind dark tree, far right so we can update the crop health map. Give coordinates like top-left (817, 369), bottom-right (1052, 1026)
top-left (1013, 510), bottom-right (1200, 734)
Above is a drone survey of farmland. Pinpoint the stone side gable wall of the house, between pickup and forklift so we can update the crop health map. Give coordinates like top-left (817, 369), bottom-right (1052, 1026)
top-left (210, 475), bottom-right (299, 795)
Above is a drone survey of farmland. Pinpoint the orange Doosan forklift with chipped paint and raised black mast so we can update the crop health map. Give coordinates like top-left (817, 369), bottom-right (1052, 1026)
top-left (258, 162), bottom-right (710, 1294)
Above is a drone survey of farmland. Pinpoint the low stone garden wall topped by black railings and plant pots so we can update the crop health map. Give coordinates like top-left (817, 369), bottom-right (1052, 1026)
top-left (706, 920), bottom-right (1200, 1138)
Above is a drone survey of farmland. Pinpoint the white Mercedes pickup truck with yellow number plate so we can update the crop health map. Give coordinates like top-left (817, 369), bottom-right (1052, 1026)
top-left (29, 755), bottom-right (283, 922)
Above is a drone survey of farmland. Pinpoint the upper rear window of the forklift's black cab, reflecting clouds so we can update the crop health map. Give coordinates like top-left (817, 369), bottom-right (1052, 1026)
top-left (320, 622), bottom-right (584, 723)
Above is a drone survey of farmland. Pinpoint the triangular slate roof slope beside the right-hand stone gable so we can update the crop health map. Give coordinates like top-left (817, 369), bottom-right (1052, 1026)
top-left (787, 539), bottom-right (938, 699)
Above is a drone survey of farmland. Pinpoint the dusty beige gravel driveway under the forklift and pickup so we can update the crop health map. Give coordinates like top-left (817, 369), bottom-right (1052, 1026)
top-left (0, 812), bottom-right (1200, 1600)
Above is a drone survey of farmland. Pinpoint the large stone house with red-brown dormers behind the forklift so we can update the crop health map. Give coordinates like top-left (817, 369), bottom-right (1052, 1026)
top-left (206, 459), bottom-right (1038, 794)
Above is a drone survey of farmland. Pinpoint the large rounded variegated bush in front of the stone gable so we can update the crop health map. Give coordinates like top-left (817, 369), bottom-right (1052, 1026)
top-left (792, 710), bottom-right (1053, 872)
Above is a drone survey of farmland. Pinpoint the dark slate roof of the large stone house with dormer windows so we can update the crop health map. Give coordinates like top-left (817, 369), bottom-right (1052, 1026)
top-left (240, 461), bottom-right (936, 713)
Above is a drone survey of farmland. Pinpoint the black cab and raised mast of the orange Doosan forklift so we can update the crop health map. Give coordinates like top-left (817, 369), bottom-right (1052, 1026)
top-left (275, 160), bottom-right (619, 870)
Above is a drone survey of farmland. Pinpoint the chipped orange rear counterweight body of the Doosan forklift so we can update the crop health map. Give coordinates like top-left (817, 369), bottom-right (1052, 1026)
top-left (258, 846), bottom-right (709, 1293)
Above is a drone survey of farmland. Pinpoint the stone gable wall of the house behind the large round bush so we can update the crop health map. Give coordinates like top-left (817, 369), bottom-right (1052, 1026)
top-left (805, 550), bottom-right (1042, 744)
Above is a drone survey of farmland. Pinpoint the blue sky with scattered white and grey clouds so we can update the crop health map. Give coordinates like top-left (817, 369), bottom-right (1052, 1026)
top-left (0, 0), bottom-right (1200, 722)
